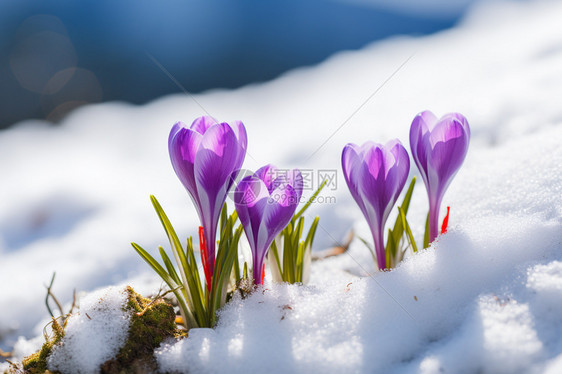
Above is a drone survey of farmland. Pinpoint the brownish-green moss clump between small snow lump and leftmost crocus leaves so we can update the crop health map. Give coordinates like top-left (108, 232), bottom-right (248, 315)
top-left (101, 287), bottom-right (182, 374)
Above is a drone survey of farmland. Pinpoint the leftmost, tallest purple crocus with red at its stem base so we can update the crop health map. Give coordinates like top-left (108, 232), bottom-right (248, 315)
top-left (168, 116), bottom-right (247, 285)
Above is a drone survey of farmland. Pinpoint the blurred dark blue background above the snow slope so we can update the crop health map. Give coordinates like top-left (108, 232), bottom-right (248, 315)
top-left (0, 0), bottom-right (470, 128)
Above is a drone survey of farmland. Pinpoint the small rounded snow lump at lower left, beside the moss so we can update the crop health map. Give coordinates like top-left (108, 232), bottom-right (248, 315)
top-left (47, 287), bottom-right (130, 374)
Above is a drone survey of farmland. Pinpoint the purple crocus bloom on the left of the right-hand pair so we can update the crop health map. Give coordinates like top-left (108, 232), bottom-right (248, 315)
top-left (342, 139), bottom-right (410, 270)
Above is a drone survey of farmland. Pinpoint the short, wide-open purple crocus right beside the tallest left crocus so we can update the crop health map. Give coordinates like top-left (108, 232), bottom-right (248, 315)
top-left (234, 165), bottom-right (302, 284)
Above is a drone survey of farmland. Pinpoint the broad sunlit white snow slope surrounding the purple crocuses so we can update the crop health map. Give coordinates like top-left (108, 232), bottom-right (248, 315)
top-left (0, 2), bottom-right (562, 373)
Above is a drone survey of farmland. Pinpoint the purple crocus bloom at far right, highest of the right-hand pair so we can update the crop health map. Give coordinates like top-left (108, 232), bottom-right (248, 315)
top-left (410, 111), bottom-right (470, 242)
